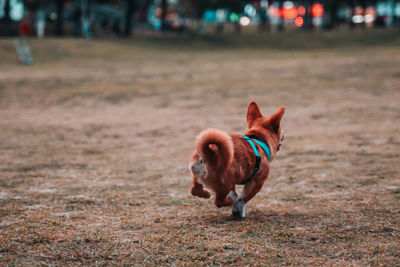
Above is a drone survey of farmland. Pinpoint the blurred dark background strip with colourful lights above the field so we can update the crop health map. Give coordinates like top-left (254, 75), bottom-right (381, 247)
top-left (0, 0), bottom-right (400, 38)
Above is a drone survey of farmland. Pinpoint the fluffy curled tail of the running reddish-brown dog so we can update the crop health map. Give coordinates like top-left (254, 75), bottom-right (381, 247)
top-left (196, 129), bottom-right (234, 175)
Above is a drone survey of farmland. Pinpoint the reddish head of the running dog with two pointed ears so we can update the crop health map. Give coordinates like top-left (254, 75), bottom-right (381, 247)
top-left (246, 102), bottom-right (285, 153)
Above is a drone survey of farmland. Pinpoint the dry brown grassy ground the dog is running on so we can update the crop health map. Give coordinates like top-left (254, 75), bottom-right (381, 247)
top-left (0, 32), bottom-right (400, 266)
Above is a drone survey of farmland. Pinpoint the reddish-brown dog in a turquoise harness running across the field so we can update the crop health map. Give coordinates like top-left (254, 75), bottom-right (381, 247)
top-left (189, 102), bottom-right (285, 218)
